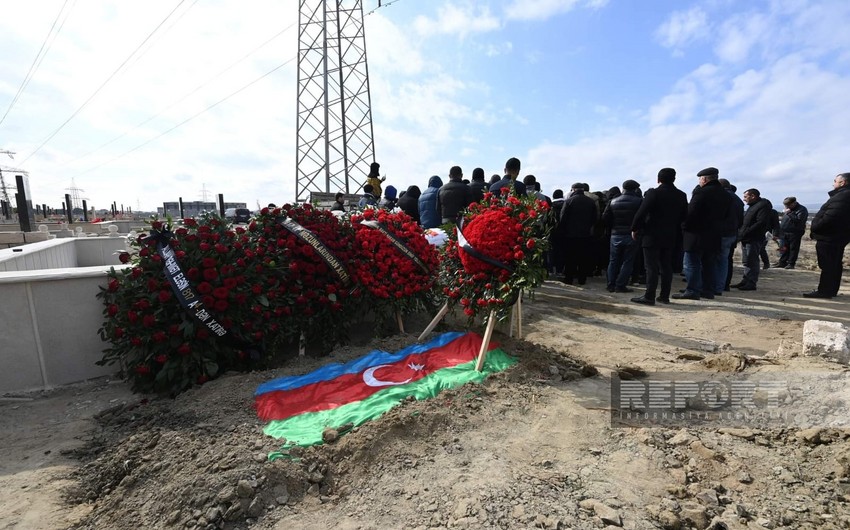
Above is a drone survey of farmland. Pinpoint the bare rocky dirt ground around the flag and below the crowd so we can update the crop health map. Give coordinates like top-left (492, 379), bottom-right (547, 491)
top-left (0, 240), bottom-right (850, 529)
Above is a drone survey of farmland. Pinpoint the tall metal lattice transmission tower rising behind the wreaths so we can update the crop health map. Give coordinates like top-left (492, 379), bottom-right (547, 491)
top-left (295, 0), bottom-right (375, 202)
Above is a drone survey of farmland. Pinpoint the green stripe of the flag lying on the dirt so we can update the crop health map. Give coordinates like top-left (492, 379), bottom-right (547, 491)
top-left (263, 348), bottom-right (517, 454)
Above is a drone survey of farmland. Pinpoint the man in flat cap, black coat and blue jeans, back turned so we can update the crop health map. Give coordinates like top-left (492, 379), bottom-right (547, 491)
top-left (673, 167), bottom-right (732, 300)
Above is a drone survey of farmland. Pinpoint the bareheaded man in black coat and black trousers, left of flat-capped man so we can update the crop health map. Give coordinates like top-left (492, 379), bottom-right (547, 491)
top-left (631, 167), bottom-right (688, 305)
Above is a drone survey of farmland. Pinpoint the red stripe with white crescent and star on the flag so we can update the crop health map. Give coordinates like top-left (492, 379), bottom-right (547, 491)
top-left (255, 333), bottom-right (490, 421)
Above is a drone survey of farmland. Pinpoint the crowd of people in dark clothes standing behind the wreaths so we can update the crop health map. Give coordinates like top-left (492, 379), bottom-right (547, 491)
top-left (333, 158), bottom-right (850, 305)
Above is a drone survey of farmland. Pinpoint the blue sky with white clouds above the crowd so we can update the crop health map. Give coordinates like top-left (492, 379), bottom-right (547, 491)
top-left (0, 0), bottom-right (850, 211)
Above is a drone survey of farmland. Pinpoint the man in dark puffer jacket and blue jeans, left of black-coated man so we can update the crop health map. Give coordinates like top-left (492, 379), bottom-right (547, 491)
top-left (602, 180), bottom-right (642, 293)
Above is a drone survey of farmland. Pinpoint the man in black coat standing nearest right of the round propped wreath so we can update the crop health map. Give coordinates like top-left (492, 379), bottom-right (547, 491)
top-left (556, 183), bottom-right (599, 285)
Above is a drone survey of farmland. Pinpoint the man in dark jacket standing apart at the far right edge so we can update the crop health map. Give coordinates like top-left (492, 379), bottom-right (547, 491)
top-left (803, 173), bottom-right (850, 298)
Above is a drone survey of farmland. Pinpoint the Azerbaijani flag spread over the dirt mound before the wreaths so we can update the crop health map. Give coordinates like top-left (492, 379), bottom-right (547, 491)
top-left (255, 332), bottom-right (516, 447)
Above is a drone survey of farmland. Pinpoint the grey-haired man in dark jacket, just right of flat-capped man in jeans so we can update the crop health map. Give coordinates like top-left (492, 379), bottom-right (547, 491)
top-left (735, 188), bottom-right (776, 291)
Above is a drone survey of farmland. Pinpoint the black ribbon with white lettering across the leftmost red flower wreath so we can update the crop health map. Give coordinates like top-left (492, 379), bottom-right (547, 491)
top-left (148, 230), bottom-right (261, 359)
